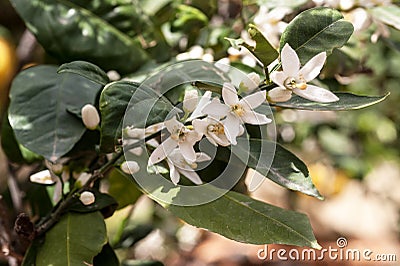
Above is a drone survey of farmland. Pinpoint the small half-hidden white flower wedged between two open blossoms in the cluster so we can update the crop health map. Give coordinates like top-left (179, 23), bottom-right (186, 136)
top-left (192, 117), bottom-right (231, 146)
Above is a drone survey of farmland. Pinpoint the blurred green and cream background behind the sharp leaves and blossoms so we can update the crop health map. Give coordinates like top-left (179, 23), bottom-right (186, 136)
top-left (0, 0), bottom-right (400, 265)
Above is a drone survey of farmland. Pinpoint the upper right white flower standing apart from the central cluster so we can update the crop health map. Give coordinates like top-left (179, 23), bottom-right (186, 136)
top-left (268, 44), bottom-right (339, 102)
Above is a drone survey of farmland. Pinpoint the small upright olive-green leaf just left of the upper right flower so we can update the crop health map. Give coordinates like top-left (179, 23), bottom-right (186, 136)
top-left (242, 24), bottom-right (278, 67)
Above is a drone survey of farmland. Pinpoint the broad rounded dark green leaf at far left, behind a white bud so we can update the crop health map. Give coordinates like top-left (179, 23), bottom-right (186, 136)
top-left (8, 65), bottom-right (101, 161)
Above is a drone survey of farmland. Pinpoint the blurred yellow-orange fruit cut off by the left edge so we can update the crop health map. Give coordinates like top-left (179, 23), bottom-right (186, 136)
top-left (0, 30), bottom-right (17, 115)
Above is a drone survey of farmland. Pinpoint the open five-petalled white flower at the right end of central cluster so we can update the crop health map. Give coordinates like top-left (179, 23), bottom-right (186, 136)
top-left (203, 83), bottom-right (271, 145)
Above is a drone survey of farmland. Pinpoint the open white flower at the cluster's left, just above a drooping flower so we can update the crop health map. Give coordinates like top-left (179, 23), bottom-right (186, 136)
top-left (149, 117), bottom-right (202, 165)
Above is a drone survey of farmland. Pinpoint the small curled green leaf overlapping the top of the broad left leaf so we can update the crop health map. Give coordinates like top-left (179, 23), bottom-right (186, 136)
top-left (57, 61), bottom-right (110, 85)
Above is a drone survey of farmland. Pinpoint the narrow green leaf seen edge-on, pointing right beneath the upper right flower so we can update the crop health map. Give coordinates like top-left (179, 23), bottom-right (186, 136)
top-left (270, 92), bottom-right (390, 111)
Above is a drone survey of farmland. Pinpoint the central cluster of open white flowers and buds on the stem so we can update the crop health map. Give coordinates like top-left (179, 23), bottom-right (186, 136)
top-left (121, 73), bottom-right (272, 185)
